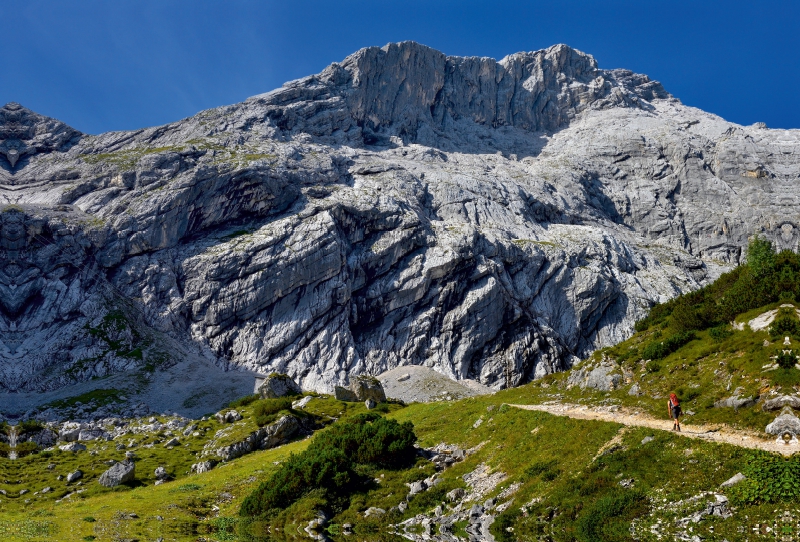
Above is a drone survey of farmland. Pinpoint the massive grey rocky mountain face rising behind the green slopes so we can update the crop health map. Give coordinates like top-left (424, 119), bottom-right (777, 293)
top-left (0, 42), bottom-right (800, 408)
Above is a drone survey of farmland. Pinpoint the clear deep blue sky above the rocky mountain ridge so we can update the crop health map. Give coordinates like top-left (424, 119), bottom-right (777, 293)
top-left (0, 0), bottom-right (800, 133)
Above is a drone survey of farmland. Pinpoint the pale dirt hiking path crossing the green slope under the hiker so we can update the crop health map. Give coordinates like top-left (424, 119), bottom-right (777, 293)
top-left (509, 403), bottom-right (800, 456)
